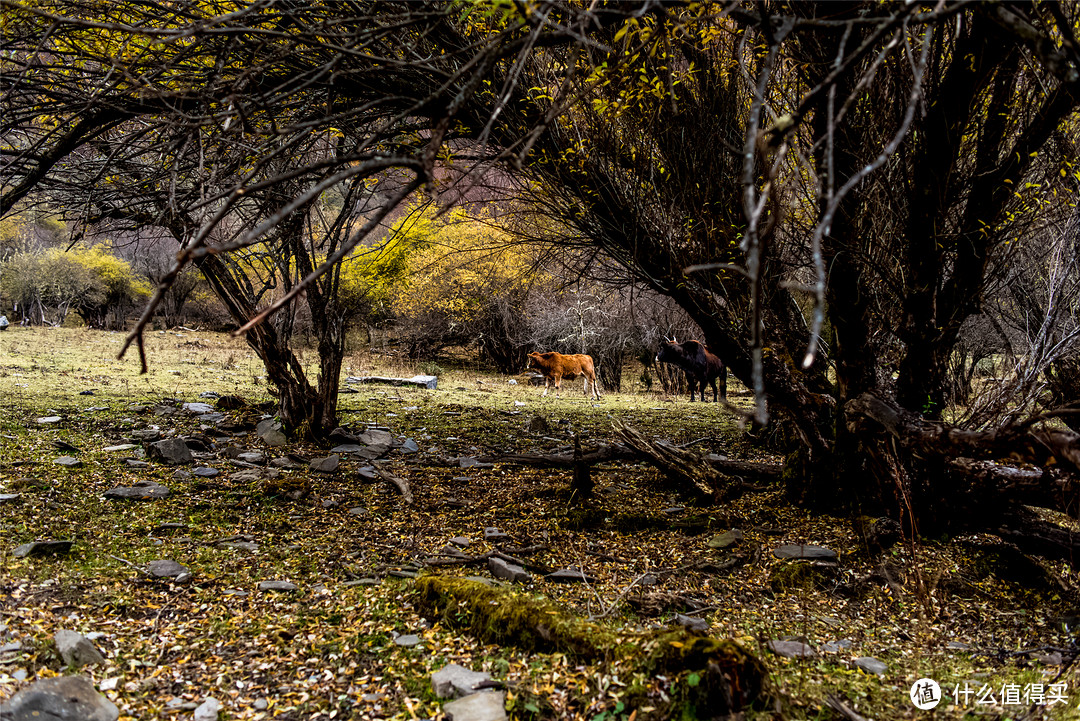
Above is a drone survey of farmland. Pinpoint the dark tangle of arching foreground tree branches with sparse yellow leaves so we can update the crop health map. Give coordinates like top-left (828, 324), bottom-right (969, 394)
top-left (0, 0), bottom-right (1080, 552)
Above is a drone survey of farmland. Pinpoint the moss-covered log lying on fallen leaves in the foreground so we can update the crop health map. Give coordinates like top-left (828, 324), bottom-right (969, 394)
top-left (416, 576), bottom-right (768, 719)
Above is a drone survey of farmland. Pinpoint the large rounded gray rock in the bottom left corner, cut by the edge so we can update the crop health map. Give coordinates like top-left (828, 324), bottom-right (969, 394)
top-left (3, 676), bottom-right (120, 721)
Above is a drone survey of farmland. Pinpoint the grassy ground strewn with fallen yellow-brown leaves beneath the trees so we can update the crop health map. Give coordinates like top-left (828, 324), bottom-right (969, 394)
top-left (0, 328), bottom-right (1080, 721)
